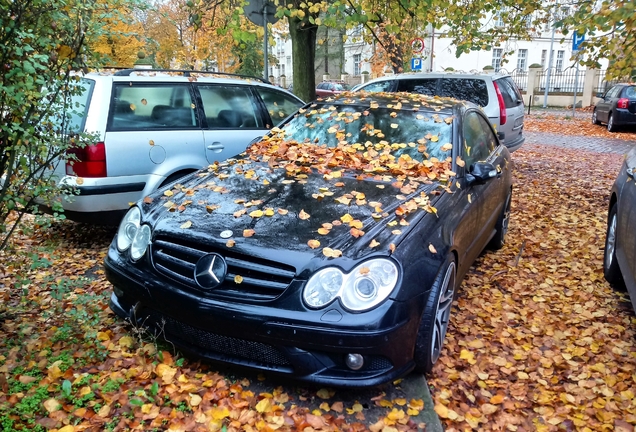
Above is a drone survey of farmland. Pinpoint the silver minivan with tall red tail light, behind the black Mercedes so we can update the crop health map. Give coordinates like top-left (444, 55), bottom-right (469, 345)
top-left (356, 72), bottom-right (525, 151)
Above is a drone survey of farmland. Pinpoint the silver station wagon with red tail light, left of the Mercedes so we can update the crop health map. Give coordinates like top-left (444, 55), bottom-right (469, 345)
top-left (45, 69), bottom-right (303, 224)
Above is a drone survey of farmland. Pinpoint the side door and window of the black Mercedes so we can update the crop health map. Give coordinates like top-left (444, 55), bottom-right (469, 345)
top-left (462, 109), bottom-right (508, 262)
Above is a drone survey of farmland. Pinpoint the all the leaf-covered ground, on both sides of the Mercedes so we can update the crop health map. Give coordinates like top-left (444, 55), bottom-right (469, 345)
top-left (0, 116), bottom-right (636, 432)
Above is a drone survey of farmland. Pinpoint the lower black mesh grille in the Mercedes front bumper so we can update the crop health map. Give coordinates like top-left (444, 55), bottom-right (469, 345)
top-left (149, 311), bottom-right (290, 367)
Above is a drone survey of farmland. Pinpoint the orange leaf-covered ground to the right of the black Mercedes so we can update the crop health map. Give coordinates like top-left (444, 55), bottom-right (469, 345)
top-left (429, 145), bottom-right (636, 431)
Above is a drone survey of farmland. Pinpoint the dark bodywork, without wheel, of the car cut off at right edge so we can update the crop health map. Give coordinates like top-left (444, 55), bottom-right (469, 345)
top-left (616, 151), bottom-right (636, 294)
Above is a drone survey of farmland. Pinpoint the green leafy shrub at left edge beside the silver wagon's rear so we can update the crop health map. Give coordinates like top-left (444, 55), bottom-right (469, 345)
top-left (0, 0), bottom-right (139, 249)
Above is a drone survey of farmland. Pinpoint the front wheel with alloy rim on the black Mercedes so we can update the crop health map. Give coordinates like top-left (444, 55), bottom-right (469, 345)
top-left (413, 255), bottom-right (456, 373)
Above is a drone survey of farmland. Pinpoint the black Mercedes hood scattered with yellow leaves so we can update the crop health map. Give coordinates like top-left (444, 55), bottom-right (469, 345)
top-left (141, 163), bottom-right (441, 274)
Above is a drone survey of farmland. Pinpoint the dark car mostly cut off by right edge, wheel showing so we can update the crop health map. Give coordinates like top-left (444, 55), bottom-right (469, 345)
top-left (603, 147), bottom-right (636, 311)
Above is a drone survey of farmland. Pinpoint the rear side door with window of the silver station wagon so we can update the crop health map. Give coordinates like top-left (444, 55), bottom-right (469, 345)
top-left (196, 84), bottom-right (268, 163)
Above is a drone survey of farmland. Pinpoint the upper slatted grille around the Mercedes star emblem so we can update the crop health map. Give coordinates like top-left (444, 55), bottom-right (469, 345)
top-left (152, 237), bottom-right (295, 300)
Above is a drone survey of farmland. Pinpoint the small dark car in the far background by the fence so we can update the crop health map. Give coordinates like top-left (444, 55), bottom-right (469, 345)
top-left (592, 83), bottom-right (636, 132)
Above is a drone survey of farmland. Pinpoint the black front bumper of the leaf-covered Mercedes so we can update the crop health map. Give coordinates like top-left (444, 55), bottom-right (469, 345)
top-left (105, 247), bottom-right (422, 387)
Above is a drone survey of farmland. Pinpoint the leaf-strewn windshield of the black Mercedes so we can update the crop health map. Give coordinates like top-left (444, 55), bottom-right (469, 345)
top-left (282, 105), bottom-right (452, 162)
